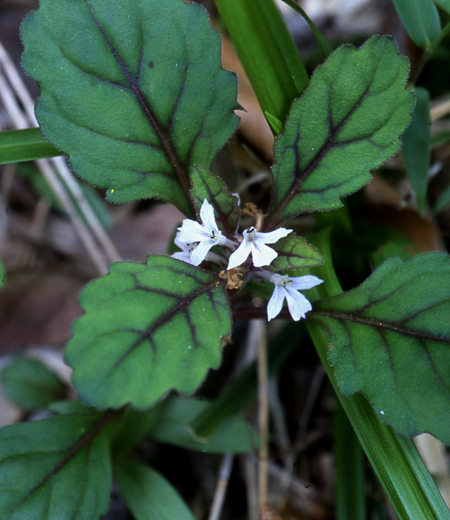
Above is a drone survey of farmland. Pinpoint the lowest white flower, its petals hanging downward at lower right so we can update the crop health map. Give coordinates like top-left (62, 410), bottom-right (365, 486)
top-left (257, 271), bottom-right (323, 321)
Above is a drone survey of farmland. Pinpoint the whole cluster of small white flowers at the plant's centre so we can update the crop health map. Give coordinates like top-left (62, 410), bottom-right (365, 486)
top-left (172, 199), bottom-right (323, 321)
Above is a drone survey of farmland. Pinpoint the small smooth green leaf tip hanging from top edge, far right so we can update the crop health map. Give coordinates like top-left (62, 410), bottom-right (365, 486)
top-left (392, 0), bottom-right (441, 47)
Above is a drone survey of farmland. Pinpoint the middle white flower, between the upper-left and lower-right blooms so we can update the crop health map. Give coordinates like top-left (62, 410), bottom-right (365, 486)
top-left (228, 227), bottom-right (292, 269)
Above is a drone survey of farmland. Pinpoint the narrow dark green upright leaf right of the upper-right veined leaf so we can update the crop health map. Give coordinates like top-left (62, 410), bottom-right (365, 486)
top-left (402, 87), bottom-right (430, 214)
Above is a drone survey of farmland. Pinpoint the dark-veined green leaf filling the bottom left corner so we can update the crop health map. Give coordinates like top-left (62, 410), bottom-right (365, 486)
top-left (0, 412), bottom-right (116, 520)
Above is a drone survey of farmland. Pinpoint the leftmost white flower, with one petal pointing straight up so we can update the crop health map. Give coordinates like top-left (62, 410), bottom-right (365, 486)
top-left (178, 199), bottom-right (235, 265)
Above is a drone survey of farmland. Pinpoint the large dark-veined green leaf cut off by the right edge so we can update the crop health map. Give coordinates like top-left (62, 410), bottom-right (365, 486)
top-left (310, 253), bottom-right (450, 444)
